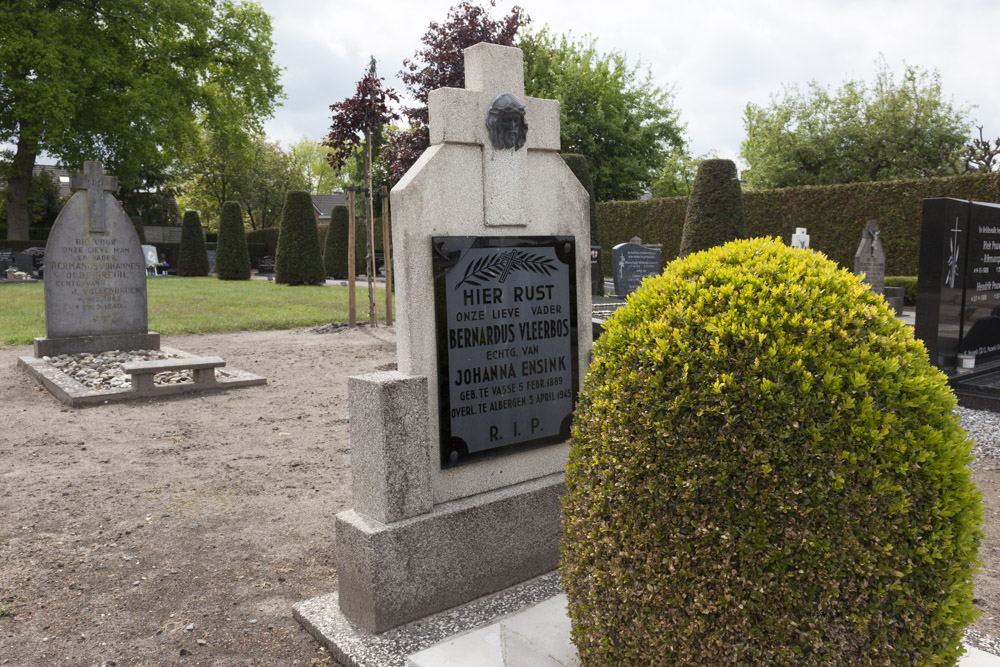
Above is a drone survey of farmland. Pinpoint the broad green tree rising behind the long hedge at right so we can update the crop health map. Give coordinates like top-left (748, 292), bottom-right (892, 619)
top-left (740, 59), bottom-right (971, 188)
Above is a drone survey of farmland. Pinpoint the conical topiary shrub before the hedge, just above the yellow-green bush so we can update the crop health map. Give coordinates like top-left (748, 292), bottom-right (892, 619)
top-left (680, 160), bottom-right (747, 257)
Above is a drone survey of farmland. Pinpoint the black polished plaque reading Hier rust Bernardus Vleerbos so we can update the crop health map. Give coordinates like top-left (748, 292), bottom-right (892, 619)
top-left (432, 236), bottom-right (579, 468)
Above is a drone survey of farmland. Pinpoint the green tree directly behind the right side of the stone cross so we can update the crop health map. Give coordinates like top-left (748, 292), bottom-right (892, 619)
top-left (518, 28), bottom-right (684, 201)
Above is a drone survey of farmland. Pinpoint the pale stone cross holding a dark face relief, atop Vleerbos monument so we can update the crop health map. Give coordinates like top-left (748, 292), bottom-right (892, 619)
top-left (427, 44), bottom-right (559, 227)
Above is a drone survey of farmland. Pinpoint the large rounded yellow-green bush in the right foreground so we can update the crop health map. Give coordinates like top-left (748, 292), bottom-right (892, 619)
top-left (560, 239), bottom-right (982, 666)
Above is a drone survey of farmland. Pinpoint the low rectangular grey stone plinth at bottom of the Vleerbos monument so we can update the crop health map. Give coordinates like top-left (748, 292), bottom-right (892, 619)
top-left (336, 473), bottom-right (564, 634)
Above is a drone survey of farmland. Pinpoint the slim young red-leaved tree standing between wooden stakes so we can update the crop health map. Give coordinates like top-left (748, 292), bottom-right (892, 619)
top-left (323, 56), bottom-right (399, 326)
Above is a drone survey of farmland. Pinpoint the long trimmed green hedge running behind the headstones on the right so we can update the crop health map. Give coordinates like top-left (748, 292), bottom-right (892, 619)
top-left (597, 173), bottom-right (1000, 276)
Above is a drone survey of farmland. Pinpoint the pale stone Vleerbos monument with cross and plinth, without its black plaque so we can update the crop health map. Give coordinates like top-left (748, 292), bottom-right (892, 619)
top-left (328, 44), bottom-right (592, 633)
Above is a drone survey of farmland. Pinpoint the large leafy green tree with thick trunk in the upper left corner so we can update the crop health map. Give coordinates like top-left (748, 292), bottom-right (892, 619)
top-left (0, 0), bottom-right (282, 239)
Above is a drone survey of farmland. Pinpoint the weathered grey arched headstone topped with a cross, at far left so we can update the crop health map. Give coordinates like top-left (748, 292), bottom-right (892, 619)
top-left (35, 162), bottom-right (160, 357)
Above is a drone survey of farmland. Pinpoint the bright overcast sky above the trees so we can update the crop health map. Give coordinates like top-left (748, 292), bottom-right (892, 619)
top-left (261, 0), bottom-right (1000, 168)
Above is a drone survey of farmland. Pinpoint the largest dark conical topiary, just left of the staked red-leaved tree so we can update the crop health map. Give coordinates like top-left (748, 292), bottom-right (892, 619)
top-left (274, 190), bottom-right (326, 285)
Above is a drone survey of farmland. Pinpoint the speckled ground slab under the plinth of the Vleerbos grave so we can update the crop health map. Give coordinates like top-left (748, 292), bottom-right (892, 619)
top-left (292, 572), bottom-right (562, 667)
